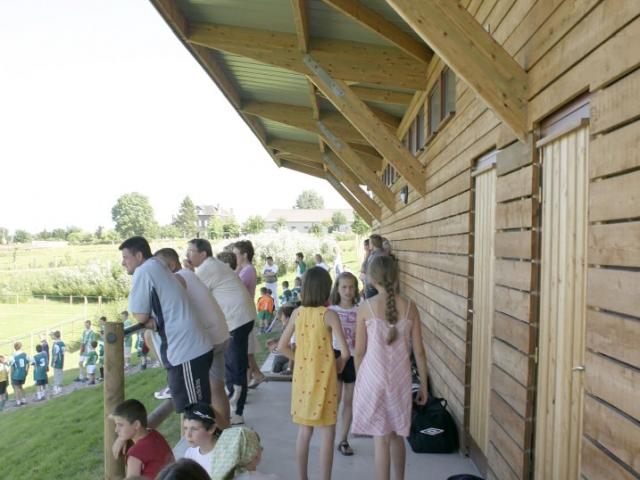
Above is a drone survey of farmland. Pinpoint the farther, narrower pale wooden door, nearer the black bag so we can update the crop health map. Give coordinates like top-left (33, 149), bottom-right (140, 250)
top-left (469, 156), bottom-right (496, 457)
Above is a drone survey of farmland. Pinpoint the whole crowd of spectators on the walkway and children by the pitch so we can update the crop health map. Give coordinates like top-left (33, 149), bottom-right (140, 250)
top-left (0, 235), bottom-right (427, 480)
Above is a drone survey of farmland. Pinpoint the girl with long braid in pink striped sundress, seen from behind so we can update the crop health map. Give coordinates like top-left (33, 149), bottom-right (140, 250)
top-left (351, 256), bottom-right (427, 480)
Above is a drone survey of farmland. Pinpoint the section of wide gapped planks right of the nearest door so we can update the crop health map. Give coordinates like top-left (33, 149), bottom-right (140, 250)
top-left (582, 64), bottom-right (640, 480)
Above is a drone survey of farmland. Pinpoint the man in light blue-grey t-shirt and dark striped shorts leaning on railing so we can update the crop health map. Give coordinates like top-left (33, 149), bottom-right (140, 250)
top-left (120, 237), bottom-right (213, 413)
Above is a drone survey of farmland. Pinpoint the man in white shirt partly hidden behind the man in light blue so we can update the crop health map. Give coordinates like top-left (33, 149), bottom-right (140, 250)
top-left (154, 248), bottom-right (229, 429)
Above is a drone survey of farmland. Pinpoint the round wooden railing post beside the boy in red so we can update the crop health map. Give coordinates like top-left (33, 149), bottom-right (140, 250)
top-left (104, 322), bottom-right (124, 480)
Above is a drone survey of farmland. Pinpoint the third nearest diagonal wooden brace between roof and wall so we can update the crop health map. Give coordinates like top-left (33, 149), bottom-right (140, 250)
top-left (318, 122), bottom-right (396, 212)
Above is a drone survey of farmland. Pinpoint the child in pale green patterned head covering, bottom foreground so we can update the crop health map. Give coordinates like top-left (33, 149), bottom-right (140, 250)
top-left (211, 427), bottom-right (278, 480)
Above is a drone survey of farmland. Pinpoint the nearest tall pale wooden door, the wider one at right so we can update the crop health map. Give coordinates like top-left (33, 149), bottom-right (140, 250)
top-left (534, 126), bottom-right (589, 480)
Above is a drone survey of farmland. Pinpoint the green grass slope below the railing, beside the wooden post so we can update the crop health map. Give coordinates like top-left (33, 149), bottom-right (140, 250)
top-left (0, 333), bottom-right (279, 480)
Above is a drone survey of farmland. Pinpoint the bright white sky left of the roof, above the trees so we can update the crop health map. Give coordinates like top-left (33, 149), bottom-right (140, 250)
top-left (0, 0), bottom-right (348, 232)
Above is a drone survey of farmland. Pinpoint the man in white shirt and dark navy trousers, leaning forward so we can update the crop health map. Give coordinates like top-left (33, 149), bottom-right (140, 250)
top-left (187, 238), bottom-right (257, 425)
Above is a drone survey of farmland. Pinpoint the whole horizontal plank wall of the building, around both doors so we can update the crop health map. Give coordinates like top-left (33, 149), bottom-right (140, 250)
top-left (375, 0), bottom-right (640, 480)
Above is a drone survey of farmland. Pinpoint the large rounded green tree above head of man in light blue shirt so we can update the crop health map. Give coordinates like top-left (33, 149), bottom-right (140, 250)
top-left (111, 192), bottom-right (158, 238)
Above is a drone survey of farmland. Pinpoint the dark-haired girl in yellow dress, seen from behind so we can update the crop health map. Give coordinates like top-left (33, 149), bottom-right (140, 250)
top-left (278, 267), bottom-right (350, 480)
